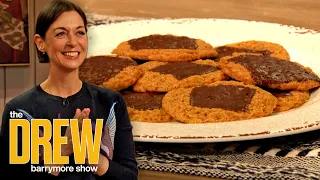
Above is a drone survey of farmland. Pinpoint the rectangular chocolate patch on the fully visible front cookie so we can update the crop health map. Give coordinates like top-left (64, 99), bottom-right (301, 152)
top-left (190, 85), bottom-right (256, 112)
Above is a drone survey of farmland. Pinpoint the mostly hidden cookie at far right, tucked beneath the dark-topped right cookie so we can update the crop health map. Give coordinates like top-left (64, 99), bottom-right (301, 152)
top-left (267, 89), bottom-right (310, 112)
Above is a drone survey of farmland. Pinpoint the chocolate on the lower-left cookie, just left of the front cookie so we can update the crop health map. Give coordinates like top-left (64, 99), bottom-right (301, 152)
top-left (122, 92), bottom-right (164, 110)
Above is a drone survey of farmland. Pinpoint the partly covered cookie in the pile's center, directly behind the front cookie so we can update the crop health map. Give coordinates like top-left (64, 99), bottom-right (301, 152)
top-left (133, 60), bottom-right (227, 92)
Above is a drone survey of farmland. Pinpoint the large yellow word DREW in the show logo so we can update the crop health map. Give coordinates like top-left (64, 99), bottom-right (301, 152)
top-left (9, 119), bottom-right (103, 164)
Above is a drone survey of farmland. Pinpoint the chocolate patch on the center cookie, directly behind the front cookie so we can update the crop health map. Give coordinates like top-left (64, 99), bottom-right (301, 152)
top-left (151, 62), bottom-right (218, 80)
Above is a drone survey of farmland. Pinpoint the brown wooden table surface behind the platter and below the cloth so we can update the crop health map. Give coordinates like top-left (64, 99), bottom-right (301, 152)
top-left (72, 0), bottom-right (320, 180)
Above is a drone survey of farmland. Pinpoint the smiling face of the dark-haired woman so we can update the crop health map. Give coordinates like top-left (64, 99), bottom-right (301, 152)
top-left (39, 11), bottom-right (88, 71)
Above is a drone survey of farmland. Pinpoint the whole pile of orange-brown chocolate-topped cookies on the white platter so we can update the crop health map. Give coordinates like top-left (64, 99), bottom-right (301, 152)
top-left (80, 34), bottom-right (320, 123)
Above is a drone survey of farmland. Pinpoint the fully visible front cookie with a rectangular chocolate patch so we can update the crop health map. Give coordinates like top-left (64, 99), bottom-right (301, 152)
top-left (162, 81), bottom-right (277, 123)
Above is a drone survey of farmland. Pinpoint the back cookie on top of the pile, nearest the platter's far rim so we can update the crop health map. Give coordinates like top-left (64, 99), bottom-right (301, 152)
top-left (112, 34), bottom-right (217, 62)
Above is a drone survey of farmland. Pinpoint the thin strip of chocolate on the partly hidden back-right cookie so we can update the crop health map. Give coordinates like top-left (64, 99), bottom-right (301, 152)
top-left (215, 46), bottom-right (271, 61)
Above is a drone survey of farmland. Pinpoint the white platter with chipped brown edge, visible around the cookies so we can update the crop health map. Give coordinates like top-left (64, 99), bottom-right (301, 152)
top-left (88, 18), bottom-right (320, 143)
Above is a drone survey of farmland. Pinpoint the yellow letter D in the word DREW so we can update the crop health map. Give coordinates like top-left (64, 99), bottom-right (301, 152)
top-left (9, 119), bottom-right (30, 164)
